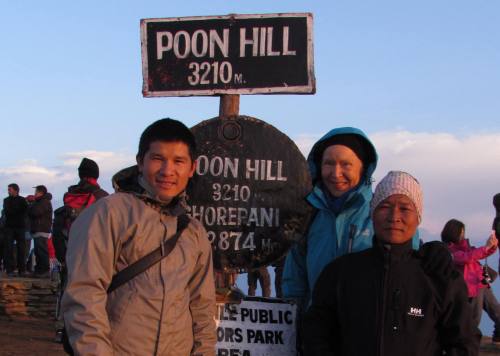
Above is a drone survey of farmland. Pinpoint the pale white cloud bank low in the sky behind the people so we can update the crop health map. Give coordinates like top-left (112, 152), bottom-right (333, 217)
top-left (0, 130), bottom-right (500, 244)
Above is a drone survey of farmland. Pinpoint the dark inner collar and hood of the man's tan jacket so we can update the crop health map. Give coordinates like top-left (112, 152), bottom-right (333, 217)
top-left (112, 165), bottom-right (189, 216)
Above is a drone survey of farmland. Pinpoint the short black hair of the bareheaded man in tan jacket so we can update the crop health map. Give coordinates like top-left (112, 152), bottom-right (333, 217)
top-left (137, 118), bottom-right (196, 161)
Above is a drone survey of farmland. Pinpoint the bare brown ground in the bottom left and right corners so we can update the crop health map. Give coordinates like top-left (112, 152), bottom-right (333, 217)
top-left (0, 319), bottom-right (500, 356)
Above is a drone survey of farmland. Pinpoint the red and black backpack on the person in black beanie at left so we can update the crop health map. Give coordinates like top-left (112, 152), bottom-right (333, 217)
top-left (52, 192), bottom-right (96, 263)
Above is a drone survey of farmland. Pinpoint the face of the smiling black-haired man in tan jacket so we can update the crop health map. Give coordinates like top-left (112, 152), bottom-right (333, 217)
top-left (137, 141), bottom-right (196, 201)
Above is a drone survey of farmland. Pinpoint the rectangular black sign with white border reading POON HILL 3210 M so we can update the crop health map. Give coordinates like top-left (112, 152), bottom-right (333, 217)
top-left (140, 13), bottom-right (316, 97)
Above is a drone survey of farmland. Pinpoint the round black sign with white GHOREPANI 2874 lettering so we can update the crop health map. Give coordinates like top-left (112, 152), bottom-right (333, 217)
top-left (187, 116), bottom-right (312, 273)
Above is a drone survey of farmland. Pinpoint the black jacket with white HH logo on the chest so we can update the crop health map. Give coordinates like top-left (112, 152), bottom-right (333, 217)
top-left (304, 236), bottom-right (479, 356)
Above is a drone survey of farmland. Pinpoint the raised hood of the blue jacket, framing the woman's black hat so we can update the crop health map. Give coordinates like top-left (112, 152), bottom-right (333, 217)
top-left (307, 127), bottom-right (378, 185)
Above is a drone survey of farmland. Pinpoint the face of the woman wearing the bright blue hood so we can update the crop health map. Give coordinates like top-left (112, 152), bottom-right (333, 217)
top-left (321, 145), bottom-right (363, 197)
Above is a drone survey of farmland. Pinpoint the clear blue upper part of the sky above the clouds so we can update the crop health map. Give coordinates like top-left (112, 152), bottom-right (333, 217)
top-left (0, 0), bottom-right (500, 149)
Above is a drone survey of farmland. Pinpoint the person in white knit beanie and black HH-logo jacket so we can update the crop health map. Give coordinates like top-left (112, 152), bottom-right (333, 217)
top-left (304, 171), bottom-right (480, 356)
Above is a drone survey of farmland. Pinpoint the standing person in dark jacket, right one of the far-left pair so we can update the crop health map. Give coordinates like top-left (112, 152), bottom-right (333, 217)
top-left (28, 185), bottom-right (52, 278)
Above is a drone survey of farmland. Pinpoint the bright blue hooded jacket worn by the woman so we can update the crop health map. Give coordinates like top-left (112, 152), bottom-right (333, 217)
top-left (282, 127), bottom-right (419, 307)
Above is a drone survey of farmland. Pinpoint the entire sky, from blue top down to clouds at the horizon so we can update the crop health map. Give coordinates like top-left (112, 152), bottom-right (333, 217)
top-left (0, 0), bottom-right (500, 334)
